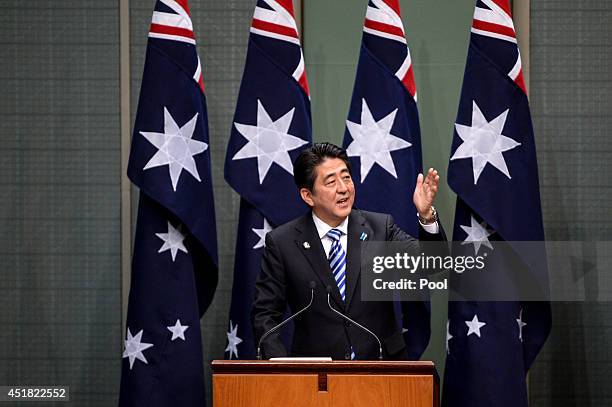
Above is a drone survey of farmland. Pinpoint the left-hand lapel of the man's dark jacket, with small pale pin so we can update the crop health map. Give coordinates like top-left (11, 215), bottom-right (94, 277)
top-left (295, 213), bottom-right (344, 308)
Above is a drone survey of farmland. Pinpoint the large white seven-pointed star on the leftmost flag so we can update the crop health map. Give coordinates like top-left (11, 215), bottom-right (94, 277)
top-left (140, 107), bottom-right (208, 191)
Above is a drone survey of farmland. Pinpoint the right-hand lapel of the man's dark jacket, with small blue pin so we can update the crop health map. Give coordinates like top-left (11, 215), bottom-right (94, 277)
top-left (346, 210), bottom-right (372, 310)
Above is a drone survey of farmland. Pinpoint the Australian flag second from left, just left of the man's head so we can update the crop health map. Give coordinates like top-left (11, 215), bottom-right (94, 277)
top-left (225, 0), bottom-right (312, 359)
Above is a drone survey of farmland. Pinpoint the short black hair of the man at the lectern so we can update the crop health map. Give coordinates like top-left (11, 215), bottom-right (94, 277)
top-left (293, 143), bottom-right (353, 191)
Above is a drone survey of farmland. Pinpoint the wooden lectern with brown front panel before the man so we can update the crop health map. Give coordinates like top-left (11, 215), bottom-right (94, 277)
top-left (212, 360), bottom-right (440, 407)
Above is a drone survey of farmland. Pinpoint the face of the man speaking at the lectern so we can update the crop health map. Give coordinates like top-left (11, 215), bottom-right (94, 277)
top-left (300, 158), bottom-right (355, 227)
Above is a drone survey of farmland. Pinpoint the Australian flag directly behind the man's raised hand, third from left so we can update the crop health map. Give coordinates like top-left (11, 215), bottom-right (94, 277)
top-left (343, 0), bottom-right (431, 359)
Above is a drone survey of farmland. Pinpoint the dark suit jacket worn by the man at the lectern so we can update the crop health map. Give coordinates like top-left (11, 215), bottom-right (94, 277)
top-left (251, 209), bottom-right (445, 359)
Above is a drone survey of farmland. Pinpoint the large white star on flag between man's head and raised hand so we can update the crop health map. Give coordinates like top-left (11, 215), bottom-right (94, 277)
top-left (346, 99), bottom-right (412, 183)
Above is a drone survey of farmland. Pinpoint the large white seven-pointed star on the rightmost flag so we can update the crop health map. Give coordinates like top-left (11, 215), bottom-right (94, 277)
top-left (451, 101), bottom-right (521, 185)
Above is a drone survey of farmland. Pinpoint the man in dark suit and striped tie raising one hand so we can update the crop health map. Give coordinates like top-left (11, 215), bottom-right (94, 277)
top-left (251, 143), bottom-right (445, 359)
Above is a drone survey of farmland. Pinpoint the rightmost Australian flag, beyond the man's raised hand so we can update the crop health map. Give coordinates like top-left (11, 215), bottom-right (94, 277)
top-left (443, 0), bottom-right (551, 407)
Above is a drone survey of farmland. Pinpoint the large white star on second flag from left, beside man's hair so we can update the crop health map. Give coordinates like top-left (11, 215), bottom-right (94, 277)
top-left (232, 99), bottom-right (308, 184)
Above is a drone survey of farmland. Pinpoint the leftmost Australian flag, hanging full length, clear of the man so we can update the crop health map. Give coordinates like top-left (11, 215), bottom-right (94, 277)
top-left (119, 0), bottom-right (217, 407)
